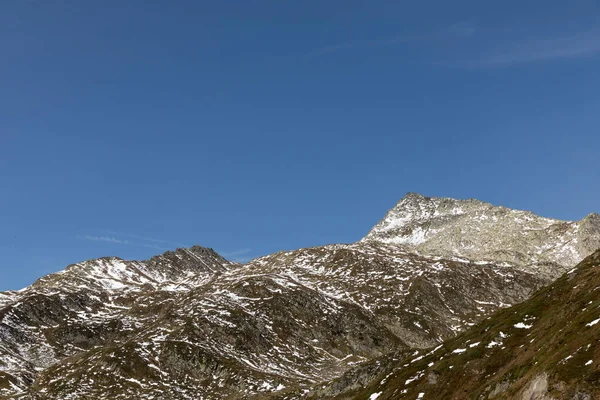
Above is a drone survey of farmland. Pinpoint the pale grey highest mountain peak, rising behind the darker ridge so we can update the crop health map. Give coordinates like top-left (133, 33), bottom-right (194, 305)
top-left (361, 193), bottom-right (600, 277)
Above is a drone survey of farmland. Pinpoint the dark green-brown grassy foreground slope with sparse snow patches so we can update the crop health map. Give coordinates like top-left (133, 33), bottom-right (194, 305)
top-left (310, 250), bottom-right (600, 400)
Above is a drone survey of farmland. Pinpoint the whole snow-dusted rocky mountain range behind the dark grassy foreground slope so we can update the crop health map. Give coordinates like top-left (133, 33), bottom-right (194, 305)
top-left (0, 194), bottom-right (600, 399)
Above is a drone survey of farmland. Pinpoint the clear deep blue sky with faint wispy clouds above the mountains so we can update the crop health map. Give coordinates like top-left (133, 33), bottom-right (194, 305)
top-left (0, 0), bottom-right (600, 290)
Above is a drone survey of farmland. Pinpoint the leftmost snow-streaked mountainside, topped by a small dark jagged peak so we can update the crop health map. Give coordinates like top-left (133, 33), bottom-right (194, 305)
top-left (0, 246), bottom-right (237, 395)
